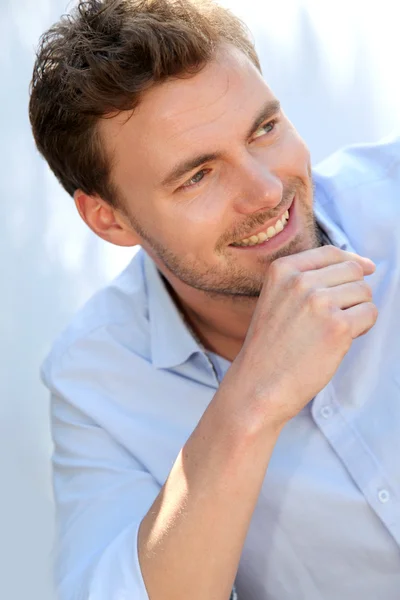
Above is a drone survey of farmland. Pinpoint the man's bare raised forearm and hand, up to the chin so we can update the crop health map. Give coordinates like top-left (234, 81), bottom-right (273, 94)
top-left (139, 247), bottom-right (377, 600)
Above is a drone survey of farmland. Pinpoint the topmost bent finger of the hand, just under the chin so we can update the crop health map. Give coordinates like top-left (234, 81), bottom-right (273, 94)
top-left (282, 246), bottom-right (375, 275)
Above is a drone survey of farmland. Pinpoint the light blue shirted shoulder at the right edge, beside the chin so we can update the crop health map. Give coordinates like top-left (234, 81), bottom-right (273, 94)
top-left (313, 136), bottom-right (400, 260)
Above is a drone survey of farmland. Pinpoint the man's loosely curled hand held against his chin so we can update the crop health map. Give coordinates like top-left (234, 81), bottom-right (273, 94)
top-left (228, 246), bottom-right (377, 427)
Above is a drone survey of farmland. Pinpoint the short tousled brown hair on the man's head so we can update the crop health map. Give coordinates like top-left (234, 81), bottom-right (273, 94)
top-left (29, 0), bottom-right (260, 205)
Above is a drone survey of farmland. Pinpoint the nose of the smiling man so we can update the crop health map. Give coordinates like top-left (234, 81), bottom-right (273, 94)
top-left (230, 156), bottom-right (283, 215)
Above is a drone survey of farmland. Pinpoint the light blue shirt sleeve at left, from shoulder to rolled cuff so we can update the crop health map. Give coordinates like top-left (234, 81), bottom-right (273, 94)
top-left (41, 329), bottom-right (235, 600)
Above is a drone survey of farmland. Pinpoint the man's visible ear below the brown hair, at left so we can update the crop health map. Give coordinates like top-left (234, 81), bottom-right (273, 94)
top-left (74, 190), bottom-right (141, 246)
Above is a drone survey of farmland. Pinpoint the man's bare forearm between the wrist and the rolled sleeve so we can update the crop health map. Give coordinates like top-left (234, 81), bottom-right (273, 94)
top-left (139, 380), bottom-right (279, 600)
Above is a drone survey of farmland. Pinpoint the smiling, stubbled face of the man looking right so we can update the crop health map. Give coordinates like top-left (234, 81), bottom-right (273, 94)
top-left (100, 47), bottom-right (318, 297)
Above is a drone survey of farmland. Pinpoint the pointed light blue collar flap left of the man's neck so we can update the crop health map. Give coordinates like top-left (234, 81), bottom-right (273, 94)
top-left (142, 250), bottom-right (200, 369)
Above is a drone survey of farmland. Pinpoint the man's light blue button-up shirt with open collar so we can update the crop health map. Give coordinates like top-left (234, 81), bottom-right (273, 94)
top-left (43, 139), bottom-right (400, 600)
